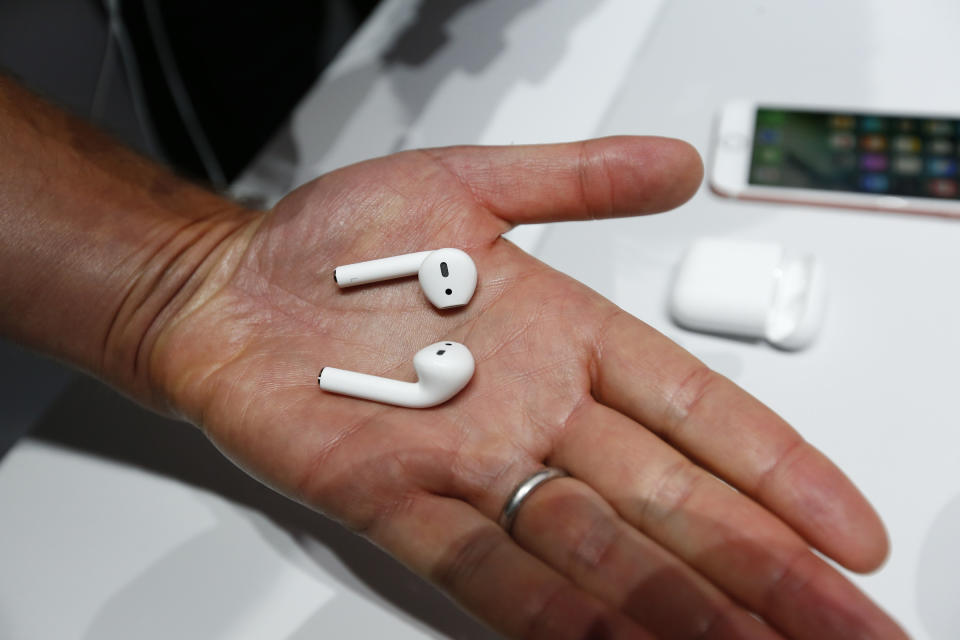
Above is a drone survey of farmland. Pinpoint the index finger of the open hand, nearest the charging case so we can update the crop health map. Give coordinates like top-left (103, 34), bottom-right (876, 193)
top-left (592, 312), bottom-right (888, 571)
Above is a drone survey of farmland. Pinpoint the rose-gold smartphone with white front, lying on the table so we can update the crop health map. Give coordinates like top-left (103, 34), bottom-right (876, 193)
top-left (710, 101), bottom-right (960, 217)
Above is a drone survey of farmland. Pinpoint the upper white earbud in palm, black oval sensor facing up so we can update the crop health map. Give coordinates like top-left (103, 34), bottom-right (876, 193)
top-left (333, 249), bottom-right (477, 309)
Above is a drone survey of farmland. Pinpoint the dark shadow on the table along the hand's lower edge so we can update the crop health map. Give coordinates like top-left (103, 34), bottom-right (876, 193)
top-left (31, 378), bottom-right (499, 640)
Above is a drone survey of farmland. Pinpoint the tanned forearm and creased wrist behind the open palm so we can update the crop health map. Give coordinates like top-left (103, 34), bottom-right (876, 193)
top-left (0, 75), bottom-right (259, 405)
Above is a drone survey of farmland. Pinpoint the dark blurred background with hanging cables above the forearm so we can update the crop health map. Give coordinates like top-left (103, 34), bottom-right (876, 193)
top-left (0, 0), bottom-right (378, 188)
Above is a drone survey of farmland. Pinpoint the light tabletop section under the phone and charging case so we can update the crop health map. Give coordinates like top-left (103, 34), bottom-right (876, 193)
top-left (536, 0), bottom-right (960, 640)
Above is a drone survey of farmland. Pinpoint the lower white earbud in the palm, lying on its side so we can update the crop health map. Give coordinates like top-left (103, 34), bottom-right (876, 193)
top-left (317, 341), bottom-right (474, 409)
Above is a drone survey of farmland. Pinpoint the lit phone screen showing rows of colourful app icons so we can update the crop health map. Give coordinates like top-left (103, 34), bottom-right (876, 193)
top-left (750, 107), bottom-right (960, 199)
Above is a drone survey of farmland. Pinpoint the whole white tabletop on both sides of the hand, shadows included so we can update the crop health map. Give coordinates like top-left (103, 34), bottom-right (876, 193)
top-left (0, 0), bottom-right (960, 640)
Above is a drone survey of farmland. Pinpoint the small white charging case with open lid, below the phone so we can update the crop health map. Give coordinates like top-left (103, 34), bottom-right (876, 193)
top-left (670, 238), bottom-right (826, 349)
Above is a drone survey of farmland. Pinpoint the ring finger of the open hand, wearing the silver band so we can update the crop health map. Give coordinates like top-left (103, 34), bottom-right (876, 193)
top-left (429, 428), bottom-right (779, 638)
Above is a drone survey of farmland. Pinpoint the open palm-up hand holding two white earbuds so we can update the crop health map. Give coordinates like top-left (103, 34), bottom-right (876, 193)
top-left (148, 138), bottom-right (903, 640)
